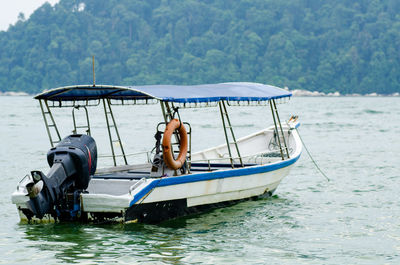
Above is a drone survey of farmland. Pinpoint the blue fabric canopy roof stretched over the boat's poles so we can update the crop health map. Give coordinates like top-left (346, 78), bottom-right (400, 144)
top-left (35, 82), bottom-right (292, 103)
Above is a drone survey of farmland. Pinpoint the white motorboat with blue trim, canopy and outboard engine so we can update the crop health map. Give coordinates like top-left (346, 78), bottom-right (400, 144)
top-left (11, 82), bottom-right (302, 224)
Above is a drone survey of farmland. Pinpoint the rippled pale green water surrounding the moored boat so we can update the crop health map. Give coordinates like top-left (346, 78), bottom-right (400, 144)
top-left (0, 97), bottom-right (400, 264)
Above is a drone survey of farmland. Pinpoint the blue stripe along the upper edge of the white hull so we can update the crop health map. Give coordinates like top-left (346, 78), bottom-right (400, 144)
top-left (129, 155), bottom-right (300, 206)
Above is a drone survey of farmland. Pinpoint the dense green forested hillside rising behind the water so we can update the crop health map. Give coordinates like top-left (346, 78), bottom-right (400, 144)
top-left (0, 0), bottom-right (400, 94)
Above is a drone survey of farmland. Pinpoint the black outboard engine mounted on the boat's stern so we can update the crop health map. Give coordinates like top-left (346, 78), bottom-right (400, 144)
top-left (26, 134), bottom-right (97, 219)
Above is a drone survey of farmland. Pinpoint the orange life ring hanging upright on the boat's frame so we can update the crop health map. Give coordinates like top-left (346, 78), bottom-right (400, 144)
top-left (162, 119), bottom-right (188, 170)
